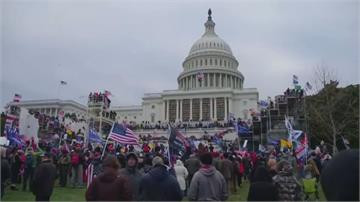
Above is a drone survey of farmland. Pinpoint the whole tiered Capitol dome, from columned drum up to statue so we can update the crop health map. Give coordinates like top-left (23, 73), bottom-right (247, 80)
top-left (178, 9), bottom-right (244, 90)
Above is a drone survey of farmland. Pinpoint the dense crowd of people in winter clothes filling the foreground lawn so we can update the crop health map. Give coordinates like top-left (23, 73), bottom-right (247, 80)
top-left (1, 137), bottom-right (359, 201)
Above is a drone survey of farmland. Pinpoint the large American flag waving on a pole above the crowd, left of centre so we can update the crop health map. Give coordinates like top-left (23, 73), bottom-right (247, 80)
top-left (108, 123), bottom-right (139, 144)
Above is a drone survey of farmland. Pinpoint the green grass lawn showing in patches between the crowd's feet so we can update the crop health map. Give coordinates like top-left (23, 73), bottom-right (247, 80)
top-left (2, 181), bottom-right (325, 201)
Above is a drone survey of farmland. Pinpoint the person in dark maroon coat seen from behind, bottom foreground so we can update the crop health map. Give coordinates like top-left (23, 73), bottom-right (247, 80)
top-left (85, 156), bottom-right (133, 201)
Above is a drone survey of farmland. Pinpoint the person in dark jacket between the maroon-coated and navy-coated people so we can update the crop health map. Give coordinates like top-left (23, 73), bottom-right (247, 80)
top-left (120, 152), bottom-right (142, 200)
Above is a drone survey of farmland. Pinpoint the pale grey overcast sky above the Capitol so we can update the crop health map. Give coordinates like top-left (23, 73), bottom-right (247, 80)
top-left (0, 0), bottom-right (359, 107)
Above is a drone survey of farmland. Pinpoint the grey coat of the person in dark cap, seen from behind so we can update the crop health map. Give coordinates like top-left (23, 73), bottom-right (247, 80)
top-left (188, 166), bottom-right (228, 201)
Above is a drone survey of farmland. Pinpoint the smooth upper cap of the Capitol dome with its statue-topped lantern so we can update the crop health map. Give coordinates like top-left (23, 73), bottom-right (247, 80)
top-left (189, 11), bottom-right (232, 56)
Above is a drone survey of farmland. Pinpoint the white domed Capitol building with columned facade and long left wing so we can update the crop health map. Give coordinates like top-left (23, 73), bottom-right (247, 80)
top-left (9, 10), bottom-right (259, 135)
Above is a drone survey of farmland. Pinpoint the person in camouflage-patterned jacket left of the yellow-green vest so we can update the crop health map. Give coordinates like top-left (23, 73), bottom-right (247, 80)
top-left (273, 161), bottom-right (302, 201)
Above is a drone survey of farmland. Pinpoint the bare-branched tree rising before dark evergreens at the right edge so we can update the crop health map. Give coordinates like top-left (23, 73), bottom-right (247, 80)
top-left (307, 64), bottom-right (359, 153)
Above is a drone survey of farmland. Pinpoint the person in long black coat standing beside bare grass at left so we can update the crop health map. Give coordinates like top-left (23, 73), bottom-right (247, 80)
top-left (31, 153), bottom-right (56, 201)
